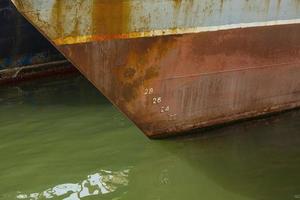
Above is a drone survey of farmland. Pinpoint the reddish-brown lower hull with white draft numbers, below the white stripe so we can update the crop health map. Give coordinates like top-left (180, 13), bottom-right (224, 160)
top-left (54, 24), bottom-right (300, 137)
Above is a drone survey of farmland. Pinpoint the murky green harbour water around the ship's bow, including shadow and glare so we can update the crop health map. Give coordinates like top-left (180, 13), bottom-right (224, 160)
top-left (0, 76), bottom-right (300, 200)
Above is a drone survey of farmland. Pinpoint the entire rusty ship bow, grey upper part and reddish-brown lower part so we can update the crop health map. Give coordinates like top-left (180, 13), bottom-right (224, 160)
top-left (12, 0), bottom-right (300, 137)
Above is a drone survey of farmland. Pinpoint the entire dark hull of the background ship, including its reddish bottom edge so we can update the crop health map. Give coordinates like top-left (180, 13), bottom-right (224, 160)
top-left (0, 0), bottom-right (70, 84)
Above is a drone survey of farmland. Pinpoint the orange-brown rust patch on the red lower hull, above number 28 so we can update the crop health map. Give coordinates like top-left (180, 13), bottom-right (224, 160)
top-left (113, 38), bottom-right (175, 105)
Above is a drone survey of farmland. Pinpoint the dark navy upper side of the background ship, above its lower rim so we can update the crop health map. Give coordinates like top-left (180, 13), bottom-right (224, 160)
top-left (0, 0), bottom-right (65, 70)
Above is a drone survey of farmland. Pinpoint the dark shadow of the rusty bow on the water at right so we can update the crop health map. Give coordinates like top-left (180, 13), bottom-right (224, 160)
top-left (162, 110), bottom-right (300, 200)
